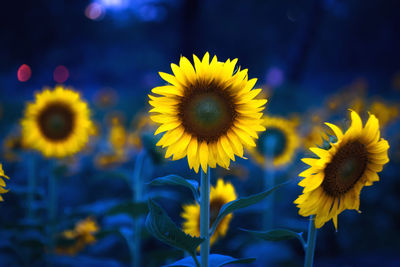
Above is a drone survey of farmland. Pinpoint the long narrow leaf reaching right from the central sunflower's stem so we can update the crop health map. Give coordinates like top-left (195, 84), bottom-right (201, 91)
top-left (210, 182), bottom-right (288, 236)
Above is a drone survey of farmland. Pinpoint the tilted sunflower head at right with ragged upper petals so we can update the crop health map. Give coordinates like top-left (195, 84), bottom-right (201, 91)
top-left (294, 111), bottom-right (389, 229)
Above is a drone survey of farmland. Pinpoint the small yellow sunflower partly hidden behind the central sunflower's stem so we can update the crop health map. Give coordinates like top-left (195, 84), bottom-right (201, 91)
top-left (181, 178), bottom-right (237, 248)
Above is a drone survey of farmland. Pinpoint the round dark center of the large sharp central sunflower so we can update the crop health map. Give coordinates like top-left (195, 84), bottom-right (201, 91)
top-left (178, 81), bottom-right (236, 142)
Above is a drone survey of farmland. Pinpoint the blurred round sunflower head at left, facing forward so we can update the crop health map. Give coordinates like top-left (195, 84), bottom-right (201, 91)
top-left (21, 86), bottom-right (92, 158)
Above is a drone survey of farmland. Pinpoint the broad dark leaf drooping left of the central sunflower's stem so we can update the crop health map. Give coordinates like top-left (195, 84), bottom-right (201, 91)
top-left (146, 199), bottom-right (204, 255)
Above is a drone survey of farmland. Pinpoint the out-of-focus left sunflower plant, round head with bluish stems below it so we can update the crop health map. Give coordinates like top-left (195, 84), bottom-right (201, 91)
top-left (21, 85), bottom-right (92, 262)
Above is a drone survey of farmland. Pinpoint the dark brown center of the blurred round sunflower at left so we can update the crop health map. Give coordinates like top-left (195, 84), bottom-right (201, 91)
top-left (38, 102), bottom-right (75, 141)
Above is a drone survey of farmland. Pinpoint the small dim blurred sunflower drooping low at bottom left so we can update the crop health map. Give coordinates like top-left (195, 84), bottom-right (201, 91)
top-left (56, 217), bottom-right (100, 256)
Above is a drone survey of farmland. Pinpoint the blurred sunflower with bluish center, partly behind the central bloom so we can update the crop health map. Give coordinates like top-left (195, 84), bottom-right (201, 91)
top-left (249, 117), bottom-right (300, 167)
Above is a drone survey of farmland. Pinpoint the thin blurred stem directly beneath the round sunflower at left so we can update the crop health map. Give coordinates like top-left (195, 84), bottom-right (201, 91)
top-left (48, 162), bottom-right (57, 265)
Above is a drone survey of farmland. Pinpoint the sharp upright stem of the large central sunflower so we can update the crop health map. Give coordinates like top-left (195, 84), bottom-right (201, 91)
top-left (200, 167), bottom-right (210, 267)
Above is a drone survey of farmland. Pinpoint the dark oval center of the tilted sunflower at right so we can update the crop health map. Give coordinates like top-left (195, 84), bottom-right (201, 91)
top-left (322, 141), bottom-right (368, 197)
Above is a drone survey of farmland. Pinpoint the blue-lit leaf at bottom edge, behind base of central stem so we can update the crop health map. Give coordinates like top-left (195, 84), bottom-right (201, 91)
top-left (165, 254), bottom-right (255, 267)
